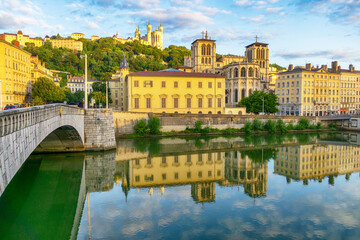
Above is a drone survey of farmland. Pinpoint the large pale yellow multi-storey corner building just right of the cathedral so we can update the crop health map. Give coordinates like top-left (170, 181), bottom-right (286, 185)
top-left (275, 64), bottom-right (340, 116)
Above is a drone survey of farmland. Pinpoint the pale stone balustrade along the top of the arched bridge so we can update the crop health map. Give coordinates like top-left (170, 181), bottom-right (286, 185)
top-left (0, 103), bottom-right (84, 137)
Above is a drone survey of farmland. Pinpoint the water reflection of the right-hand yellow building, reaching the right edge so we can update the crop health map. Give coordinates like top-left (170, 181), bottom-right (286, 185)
top-left (274, 144), bottom-right (360, 185)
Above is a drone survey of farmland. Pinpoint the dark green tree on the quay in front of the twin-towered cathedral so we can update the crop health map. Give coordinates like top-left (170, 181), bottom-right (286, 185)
top-left (237, 91), bottom-right (279, 114)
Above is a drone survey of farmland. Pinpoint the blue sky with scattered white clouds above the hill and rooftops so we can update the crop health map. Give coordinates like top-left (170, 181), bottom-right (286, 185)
top-left (0, 0), bottom-right (360, 70)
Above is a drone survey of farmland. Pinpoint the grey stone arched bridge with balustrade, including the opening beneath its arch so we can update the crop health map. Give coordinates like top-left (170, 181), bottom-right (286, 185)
top-left (0, 104), bottom-right (85, 196)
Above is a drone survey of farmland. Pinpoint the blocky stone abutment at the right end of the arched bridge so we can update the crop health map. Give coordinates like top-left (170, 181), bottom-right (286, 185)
top-left (84, 109), bottom-right (116, 151)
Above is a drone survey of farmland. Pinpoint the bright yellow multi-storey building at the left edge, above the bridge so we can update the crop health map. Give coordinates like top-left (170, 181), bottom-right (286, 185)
top-left (0, 40), bottom-right (31, 108)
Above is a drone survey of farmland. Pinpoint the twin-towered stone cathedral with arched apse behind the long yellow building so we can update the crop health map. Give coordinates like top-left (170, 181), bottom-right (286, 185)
top-left (184, 31), bottom-right (269, 107)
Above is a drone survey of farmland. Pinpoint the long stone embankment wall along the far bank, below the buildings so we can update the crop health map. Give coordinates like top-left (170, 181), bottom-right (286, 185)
top-left (113, 111), bottom-right (318, 137)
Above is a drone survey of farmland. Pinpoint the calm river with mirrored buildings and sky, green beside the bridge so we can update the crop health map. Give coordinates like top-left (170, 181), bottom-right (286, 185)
top-left (0, 133), bottom-right (360, 239)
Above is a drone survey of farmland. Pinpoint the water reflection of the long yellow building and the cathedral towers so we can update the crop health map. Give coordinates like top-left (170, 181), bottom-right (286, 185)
top-left (115, 136), bottom-right (275, 203)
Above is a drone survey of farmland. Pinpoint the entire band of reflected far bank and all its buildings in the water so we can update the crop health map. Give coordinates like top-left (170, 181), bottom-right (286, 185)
top-left (115, 134), bottom-right (360, 203)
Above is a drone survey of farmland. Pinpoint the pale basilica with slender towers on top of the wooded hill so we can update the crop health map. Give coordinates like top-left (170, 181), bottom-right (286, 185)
top-left (113, 21), bottom-right (164, 50)
